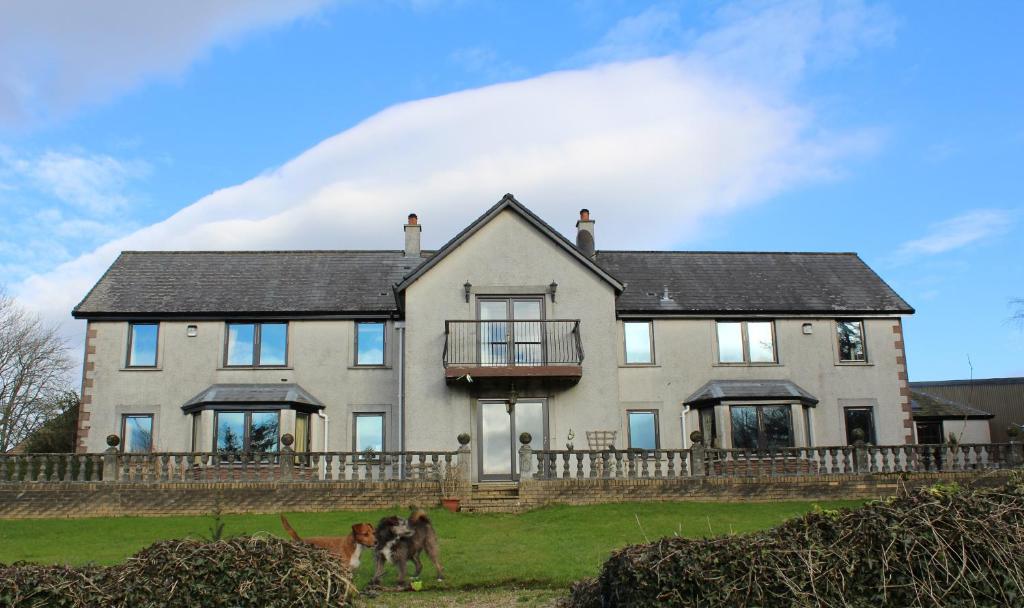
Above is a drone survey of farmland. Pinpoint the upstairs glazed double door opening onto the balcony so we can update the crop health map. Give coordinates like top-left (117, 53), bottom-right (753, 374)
top-left (477, 297), bottom-right (544, 365)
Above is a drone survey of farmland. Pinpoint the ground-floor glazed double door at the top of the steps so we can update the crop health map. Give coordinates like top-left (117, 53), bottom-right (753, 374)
top-left (478, 399), bottom-right (548, 481)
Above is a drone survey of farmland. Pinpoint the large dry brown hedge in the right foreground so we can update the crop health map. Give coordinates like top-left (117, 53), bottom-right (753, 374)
top-left (567, 479), bottom-right (1024, 608)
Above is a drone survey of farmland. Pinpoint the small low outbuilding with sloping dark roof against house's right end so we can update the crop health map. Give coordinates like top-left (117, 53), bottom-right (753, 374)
top-left (910, 384), bottom-right (995, 444)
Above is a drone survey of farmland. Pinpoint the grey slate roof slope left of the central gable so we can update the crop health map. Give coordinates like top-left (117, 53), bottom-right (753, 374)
top-left (74, 251), bottom-right (429, 317)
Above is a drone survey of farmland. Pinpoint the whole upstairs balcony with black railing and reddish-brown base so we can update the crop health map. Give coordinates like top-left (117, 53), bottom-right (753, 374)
top-left (443, 319), bottom-right (583, 384)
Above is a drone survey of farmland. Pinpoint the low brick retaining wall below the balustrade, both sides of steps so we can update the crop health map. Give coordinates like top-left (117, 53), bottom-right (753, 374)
top-left (0, 471), bottom-right (1009, 519)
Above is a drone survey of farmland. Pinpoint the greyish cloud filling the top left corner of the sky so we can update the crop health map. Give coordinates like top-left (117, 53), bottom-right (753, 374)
top-left (0, 0), bottom-right (327, 124)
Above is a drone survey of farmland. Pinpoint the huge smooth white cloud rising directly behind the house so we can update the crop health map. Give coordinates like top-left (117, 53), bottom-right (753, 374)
top-left (11, 0), bottom-right (888, 358)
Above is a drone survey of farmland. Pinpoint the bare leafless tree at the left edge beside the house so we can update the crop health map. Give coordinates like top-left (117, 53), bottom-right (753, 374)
top-left (0, 292), bottom-right (72, 452)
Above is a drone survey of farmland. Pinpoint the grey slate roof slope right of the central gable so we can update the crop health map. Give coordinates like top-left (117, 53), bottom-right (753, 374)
top-left (597, 251), bottom-right (913, 314)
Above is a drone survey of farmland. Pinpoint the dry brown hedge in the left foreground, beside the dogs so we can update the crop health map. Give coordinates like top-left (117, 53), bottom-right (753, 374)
top-left (0, 536), bottom-right (354, 608)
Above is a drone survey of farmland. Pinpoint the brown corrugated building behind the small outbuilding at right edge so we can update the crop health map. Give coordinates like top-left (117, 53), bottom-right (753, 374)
top-left (910, 378), bottom-right (1024, 443)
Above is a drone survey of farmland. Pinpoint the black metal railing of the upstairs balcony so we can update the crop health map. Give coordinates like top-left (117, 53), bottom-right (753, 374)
top-left (443, 319), bottom-right (583, 367)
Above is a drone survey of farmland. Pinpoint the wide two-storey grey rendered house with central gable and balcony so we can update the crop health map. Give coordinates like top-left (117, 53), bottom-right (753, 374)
top-left (74, 194), bottom-right (913, 481)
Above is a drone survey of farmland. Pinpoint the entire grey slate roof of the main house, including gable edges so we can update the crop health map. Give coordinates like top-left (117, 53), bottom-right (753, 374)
top-left (73, 199), bottom-right (913, 318)
